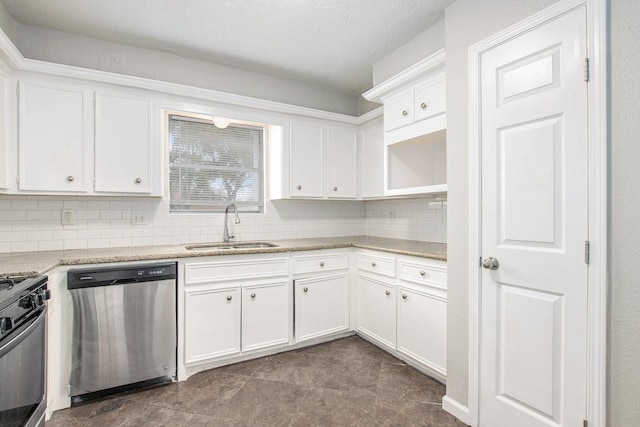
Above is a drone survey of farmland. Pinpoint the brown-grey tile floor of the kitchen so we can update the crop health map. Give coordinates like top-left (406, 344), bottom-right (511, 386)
top-left (46, 337), bottom-right (464, 427)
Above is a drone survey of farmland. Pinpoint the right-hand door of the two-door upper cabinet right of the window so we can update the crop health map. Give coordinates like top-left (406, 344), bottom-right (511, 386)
top-left (326, 127), bottom-right (358, 198)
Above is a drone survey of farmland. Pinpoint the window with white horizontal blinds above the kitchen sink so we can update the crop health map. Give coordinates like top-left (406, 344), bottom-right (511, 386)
top-left (169, 115), bottom-right (265, 212)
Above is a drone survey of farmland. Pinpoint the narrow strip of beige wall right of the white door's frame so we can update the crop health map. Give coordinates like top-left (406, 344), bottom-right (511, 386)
top-left (607, 0), bottom-right (640, 427)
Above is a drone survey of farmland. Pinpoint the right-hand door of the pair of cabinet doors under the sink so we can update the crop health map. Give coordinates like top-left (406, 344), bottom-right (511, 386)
top-left (242, 281), bottom-right (289, 351)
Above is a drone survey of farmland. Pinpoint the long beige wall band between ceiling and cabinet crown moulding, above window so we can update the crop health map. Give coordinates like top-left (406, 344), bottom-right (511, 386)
top-left (10, 25), bottom-right (358, 116)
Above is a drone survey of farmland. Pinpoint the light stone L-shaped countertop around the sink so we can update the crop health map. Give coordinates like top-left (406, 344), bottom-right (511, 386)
top-left (0, 236), bottom-right (447, 277)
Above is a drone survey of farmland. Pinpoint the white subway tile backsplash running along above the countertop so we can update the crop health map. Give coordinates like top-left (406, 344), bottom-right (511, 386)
top-left (0, 196), bottom-right (446, 253)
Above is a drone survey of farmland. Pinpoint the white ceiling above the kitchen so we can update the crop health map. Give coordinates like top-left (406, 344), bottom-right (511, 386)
top-left (0, 0), bottom-right (453, 93)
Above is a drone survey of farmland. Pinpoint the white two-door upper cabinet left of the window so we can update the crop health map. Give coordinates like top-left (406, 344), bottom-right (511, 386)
top-left (9, 79), bottom-right (162, 196)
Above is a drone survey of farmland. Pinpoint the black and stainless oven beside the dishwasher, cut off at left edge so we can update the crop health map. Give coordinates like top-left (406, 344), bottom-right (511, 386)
top-left (0, 276), bottom-right (49, 427)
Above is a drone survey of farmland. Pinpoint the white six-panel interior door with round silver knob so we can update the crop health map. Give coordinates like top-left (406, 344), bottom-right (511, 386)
top-left (479, 7), bottom-right (588, 427)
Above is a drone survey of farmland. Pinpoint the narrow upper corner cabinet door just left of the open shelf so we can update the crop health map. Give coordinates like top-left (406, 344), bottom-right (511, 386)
top-left (360, 120), bottom-right (385, 198)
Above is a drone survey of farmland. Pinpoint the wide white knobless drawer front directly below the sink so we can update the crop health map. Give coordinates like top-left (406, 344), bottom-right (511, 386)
top-left (184, 258), bottom-right (289, 285)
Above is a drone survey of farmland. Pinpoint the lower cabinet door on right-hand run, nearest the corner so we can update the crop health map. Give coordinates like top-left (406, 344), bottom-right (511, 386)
top-left (358, 276), bottom-right (396, 350)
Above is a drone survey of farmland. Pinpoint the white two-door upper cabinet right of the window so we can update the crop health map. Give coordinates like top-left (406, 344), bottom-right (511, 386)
top-left (270, 120), bottom-right (358, 199)
